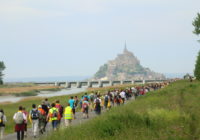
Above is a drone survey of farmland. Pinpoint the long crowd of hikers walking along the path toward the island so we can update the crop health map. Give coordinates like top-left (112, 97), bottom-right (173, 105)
top-left (0, 83), bottom-right (168, 140)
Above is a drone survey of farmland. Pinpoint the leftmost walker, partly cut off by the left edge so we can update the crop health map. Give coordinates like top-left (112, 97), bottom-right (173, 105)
top-left (0, 109), bottom-right (7, 140)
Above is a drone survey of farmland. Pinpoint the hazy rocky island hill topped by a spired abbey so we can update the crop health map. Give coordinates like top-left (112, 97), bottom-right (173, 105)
top-left (93, 45), bottom-right (165, 80)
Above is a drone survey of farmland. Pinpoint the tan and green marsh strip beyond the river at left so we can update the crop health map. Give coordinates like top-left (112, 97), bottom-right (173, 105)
top-left (0, 83), bottom-right (60, 96)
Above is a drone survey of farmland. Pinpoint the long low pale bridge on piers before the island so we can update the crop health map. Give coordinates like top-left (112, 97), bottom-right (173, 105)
top-left (34, 79), bottom-right (167, 88)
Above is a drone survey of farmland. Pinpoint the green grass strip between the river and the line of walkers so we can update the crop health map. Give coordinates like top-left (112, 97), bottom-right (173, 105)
top-left (0, 85), bottom-right (134, 134)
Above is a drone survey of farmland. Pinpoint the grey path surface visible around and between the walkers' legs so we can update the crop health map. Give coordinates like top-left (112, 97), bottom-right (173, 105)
top-left (4, 97), bottom-right (135, 140)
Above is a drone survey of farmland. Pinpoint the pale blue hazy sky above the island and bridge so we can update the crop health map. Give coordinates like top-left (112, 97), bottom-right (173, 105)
top-left (0, 0), bottom-right (200, 79)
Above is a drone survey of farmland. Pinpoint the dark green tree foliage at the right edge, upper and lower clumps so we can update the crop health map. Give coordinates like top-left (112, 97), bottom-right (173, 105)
top-left (192, 13), bottom-right (200, 80)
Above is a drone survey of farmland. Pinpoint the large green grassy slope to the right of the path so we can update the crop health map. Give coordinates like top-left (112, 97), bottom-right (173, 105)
top-left (44, 81), bottom-right (200, 140)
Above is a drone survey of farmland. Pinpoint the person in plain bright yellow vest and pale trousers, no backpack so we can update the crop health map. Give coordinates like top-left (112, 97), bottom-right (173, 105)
top-left (64, 103), bottom-right (73, 127)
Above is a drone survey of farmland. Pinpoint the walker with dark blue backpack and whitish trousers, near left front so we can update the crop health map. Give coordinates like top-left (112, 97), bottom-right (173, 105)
top-left (29, 104), bottom-right (39, 138)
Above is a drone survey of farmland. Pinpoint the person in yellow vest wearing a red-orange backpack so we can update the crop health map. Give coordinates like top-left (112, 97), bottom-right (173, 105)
top-left (47, 103), bottom-right (60, 130)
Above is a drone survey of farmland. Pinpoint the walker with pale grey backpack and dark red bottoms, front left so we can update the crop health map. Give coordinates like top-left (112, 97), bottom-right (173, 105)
top-left (13, 106), bottom-right (27, 140)
